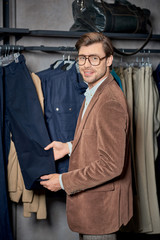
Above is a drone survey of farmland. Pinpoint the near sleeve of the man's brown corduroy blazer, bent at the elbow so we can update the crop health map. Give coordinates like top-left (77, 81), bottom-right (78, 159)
top-left (62, 100), bottom-right (128, 195)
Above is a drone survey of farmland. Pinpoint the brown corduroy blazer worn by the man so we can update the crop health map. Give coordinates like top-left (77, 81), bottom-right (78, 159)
top-left (62, 74), bottom-right (133, 235)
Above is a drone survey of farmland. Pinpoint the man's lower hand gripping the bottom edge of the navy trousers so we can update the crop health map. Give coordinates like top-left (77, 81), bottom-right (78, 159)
top-left (40, 173), bottom-right (61, 192)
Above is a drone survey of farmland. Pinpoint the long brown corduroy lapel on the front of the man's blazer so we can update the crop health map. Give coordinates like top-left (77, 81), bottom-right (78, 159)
top-left (72, 74), bottom-right (113, 152)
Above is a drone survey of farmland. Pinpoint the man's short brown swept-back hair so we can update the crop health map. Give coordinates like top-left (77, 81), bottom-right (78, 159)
top-left (75, 32), bottom-right (114, 57)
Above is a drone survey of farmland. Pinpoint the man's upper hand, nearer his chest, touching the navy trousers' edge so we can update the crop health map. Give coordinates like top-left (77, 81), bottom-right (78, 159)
top-left (44, 141), bottom-right (69, 160)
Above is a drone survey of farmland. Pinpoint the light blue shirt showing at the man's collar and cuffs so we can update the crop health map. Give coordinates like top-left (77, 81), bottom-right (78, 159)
top-left (59, 78), bottom-right (106, 190)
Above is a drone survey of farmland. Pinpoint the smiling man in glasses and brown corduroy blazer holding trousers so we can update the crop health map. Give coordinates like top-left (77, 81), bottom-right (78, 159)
top-left (41, 32), bottom-right (132, 240)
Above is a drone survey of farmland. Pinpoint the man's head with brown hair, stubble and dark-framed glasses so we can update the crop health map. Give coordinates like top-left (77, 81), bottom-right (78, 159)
top-left (76, 32), bottom-right (113, 88)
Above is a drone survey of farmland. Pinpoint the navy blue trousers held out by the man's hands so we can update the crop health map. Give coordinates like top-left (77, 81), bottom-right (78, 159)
top-left (3, 55), bottom-right (55, 189)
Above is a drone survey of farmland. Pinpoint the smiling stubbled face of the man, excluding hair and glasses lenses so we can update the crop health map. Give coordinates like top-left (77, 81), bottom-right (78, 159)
top-left (79, 43), bottom-right (111, 88)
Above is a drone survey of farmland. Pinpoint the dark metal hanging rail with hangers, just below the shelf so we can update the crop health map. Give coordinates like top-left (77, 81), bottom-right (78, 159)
top-left (0, 45), bottom-right (160, 56)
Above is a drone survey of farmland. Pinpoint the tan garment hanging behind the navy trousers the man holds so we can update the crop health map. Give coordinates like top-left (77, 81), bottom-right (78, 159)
top-left (8, 73), bottom-right (47, 219)
